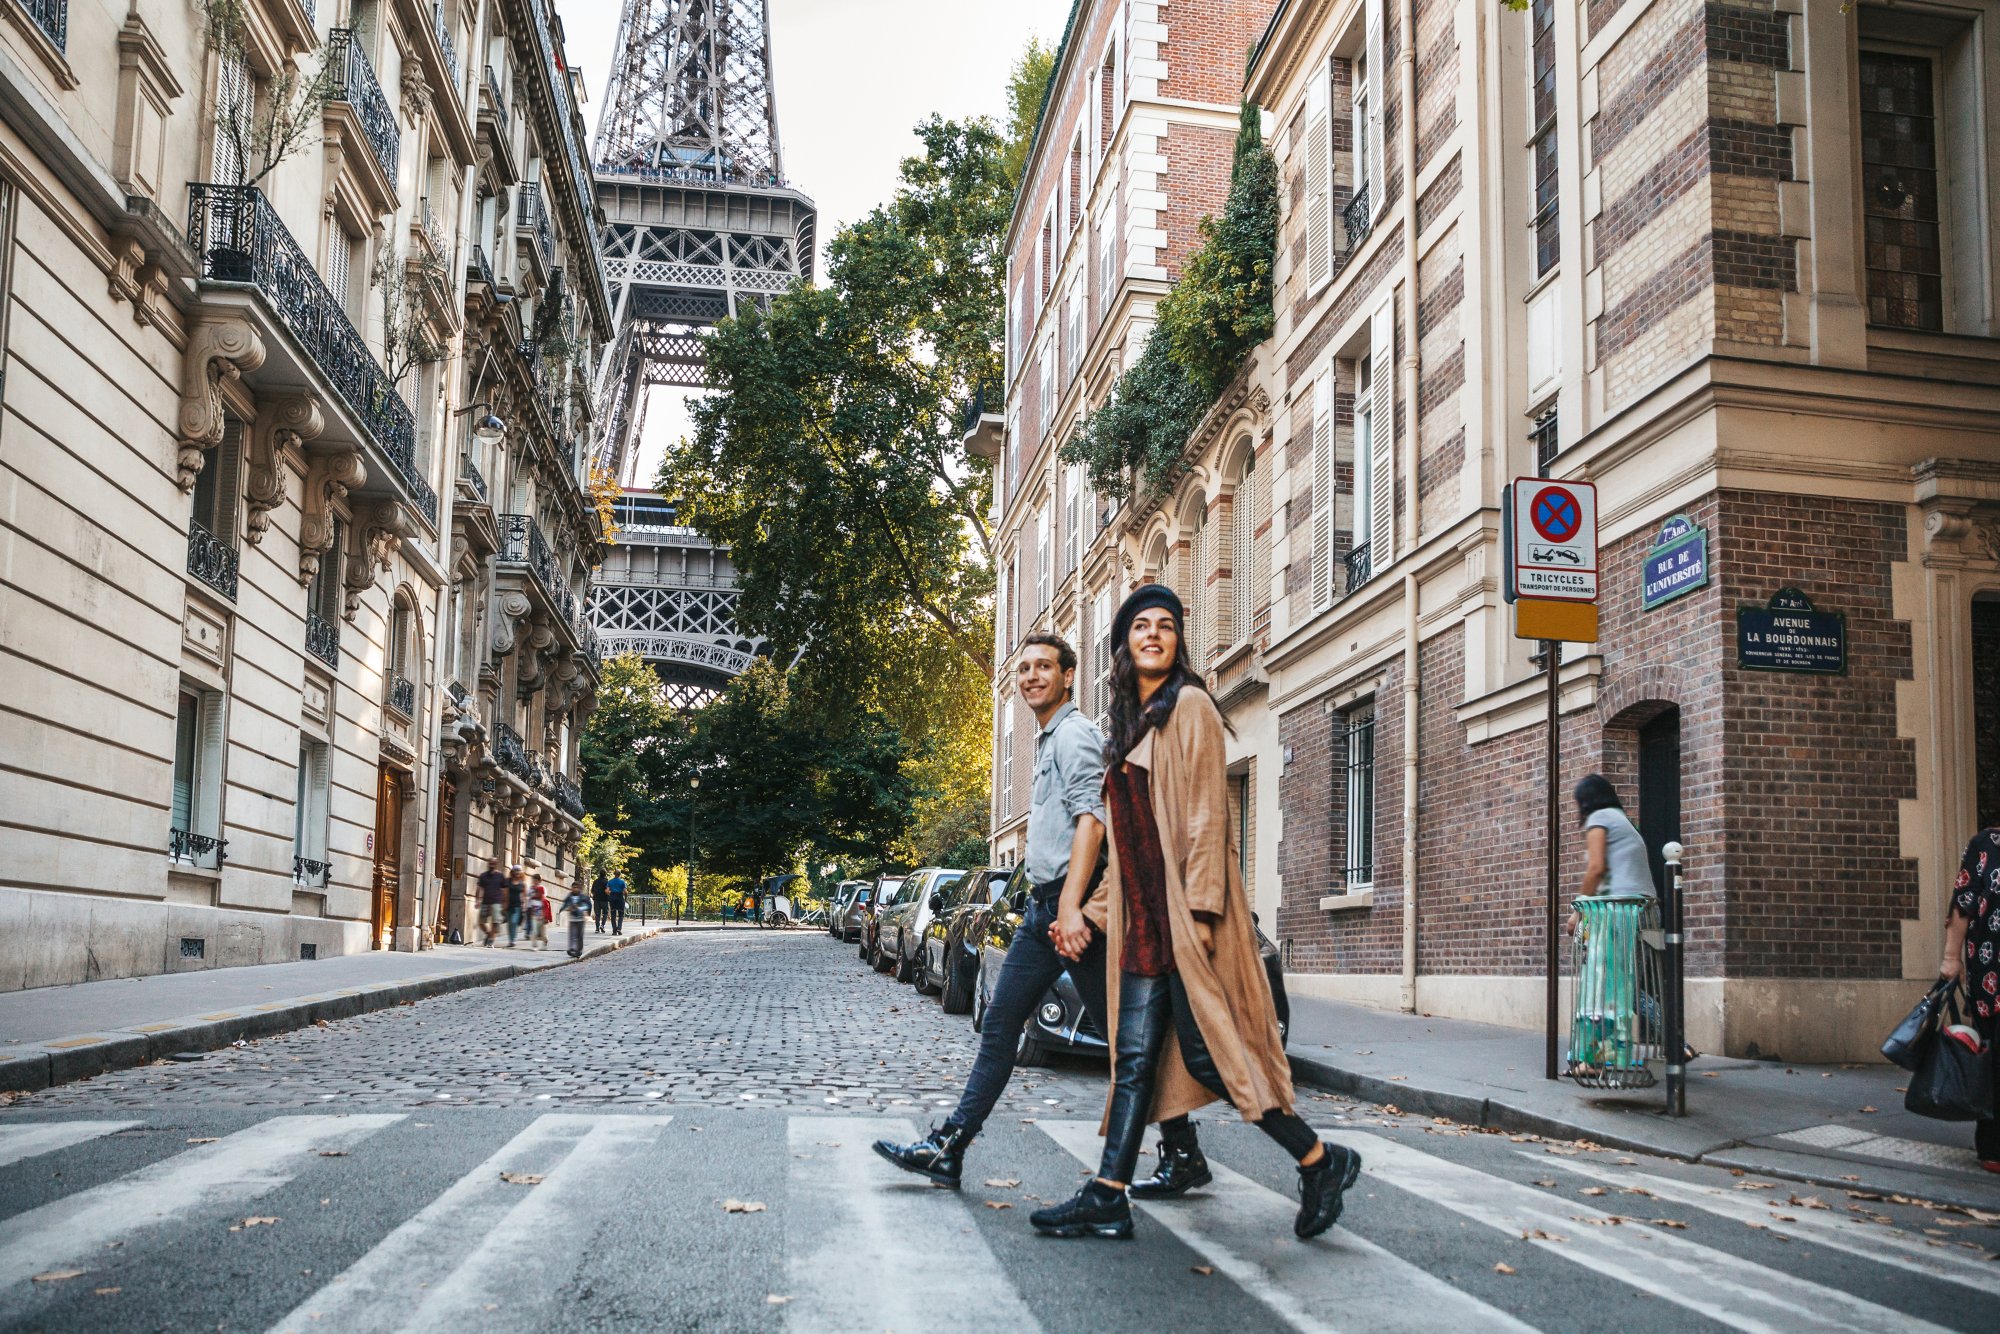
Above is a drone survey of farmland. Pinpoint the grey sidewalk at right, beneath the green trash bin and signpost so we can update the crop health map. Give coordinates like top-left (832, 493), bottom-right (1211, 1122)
top-left (1286, 996), bottom-right (2000, 1210)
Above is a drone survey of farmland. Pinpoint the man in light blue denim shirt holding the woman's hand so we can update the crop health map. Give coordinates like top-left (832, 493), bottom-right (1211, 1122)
top-left (874, 634), bottom-right (1210, 1200)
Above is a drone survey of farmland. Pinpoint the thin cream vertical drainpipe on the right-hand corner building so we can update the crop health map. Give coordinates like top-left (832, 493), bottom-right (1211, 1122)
top-left (1392, 0), bottom-right (1422, 1012)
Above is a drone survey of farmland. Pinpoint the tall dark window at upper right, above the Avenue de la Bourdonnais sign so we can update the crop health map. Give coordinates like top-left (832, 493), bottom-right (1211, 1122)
top-left (1860, 50), bottom-right (1944, 332)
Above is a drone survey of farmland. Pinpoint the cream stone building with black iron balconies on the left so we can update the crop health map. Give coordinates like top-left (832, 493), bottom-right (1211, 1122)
top-left (0, 0), bottom-right (608, 988)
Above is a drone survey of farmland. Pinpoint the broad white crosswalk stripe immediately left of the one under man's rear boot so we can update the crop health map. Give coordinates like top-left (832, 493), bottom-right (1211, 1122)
top-left (272, 1114), bottom-right (674, 1334)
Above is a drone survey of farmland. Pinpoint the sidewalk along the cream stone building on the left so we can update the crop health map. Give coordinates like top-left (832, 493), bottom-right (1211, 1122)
top-left (0, 920), bottom-right (714, 1092)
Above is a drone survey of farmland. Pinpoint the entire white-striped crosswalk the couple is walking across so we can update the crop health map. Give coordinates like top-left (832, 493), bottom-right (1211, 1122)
top-left (0, 1108), bottom-right (2000, 1334)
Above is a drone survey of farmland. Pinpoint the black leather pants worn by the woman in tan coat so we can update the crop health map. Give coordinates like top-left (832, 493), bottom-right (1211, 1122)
top-left (1098, 972), bottom-right (1320, 1184)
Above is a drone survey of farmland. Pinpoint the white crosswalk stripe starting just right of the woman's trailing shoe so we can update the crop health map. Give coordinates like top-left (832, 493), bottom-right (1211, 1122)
top-left (1334, 1130), bottom-right (1940, 1334)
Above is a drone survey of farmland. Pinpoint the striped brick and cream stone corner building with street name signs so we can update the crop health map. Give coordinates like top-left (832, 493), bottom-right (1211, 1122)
top-left (996, 0), bottom-right (2000, 1060)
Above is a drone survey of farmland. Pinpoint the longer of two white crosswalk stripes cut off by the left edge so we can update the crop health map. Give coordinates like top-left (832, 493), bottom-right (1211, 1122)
top-left (0, 1114), bottom-right (402, 1310)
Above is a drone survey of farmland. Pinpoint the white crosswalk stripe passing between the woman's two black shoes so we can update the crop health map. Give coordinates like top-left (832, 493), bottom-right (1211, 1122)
top-left (1038, 1120), bottom-right (1532, 1332)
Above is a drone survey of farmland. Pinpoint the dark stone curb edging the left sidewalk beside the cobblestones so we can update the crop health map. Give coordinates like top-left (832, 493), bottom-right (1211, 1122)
top-left (0, 928), bottom-right (676, 1094)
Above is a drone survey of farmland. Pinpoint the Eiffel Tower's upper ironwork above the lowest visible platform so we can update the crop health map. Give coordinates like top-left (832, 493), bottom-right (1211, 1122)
top-left (594, 0), bottom-right (816, 484)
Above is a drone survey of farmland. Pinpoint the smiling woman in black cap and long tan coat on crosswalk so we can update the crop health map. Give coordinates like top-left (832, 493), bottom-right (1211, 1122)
top-left (1030, 584), bottom-right (1362, 1238)
